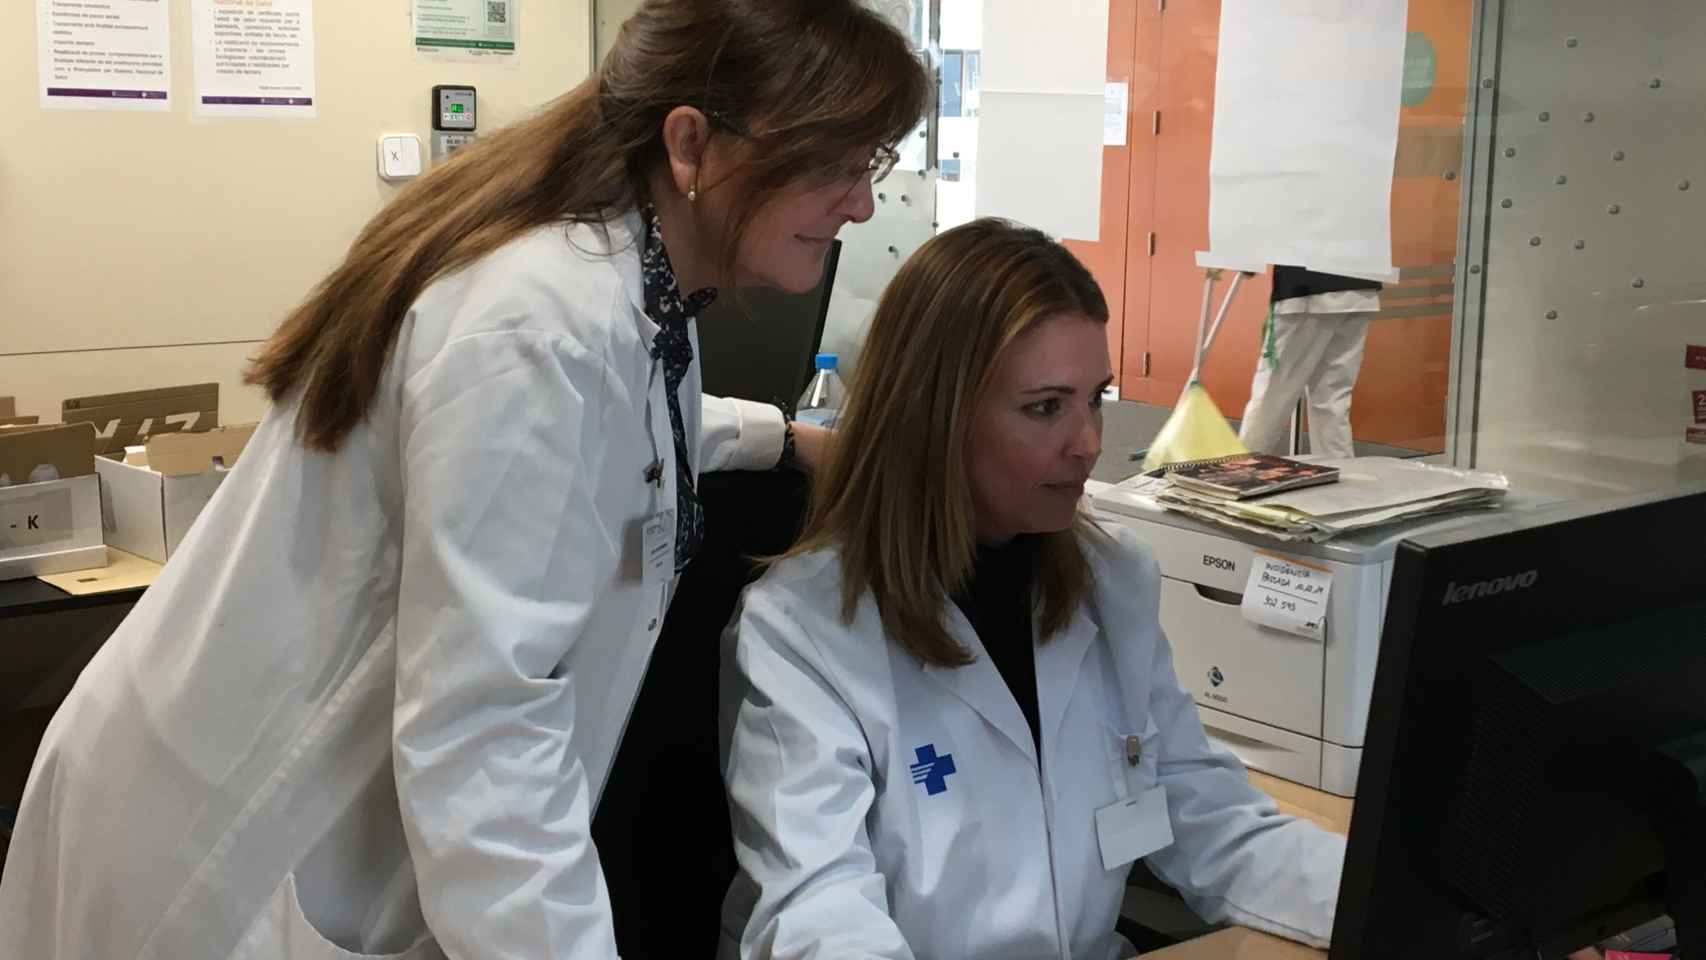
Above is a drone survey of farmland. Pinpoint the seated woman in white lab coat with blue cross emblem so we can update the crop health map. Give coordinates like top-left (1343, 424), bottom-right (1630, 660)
top-left (722, 220), bottom-right (1344, 960)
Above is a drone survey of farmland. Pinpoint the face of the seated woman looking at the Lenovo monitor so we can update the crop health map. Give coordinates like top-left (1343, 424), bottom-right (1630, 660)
top-left (966, 314), bottom-right (1114, 542)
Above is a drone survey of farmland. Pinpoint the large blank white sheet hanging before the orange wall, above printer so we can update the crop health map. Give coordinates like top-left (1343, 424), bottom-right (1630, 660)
top-left (1208, 0), bottom-right (1407, 280)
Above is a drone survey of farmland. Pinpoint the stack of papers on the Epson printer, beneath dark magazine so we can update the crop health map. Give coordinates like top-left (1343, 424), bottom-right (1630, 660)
top-left (1150, 457), bottom-right (1510, 544)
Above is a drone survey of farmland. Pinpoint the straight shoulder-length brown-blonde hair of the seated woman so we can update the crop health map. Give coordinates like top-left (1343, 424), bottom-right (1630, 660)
top-left (786, 220), bottom-right (1107, 667)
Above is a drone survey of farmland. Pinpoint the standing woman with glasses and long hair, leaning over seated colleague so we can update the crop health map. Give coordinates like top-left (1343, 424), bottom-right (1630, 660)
top-left (0, 0), bottom-right (925, 960)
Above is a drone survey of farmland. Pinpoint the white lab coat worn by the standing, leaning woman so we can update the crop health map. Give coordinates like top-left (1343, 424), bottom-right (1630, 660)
top-left (0, 215), bottom-right (783, 960)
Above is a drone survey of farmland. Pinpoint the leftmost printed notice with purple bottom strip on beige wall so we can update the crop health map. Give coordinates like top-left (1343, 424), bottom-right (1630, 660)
top-left (36, 0), bottom-right (172, 111)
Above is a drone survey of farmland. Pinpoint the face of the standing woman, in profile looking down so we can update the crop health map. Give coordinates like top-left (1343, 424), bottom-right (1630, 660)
top-left (735, 150), bottom-right (875, 293)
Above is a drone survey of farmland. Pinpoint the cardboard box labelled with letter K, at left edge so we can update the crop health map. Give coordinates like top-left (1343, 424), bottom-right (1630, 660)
top-left (0, 423), bottom-right (106, 580)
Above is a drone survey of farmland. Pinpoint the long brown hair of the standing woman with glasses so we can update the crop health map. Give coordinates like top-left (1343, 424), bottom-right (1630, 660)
top-left (247, 0), bottom-right (928, 450)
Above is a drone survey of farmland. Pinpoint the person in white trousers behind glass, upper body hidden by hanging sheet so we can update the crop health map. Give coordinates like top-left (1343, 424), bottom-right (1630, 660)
top-left (1239, 266), bottom-right (1380, 459)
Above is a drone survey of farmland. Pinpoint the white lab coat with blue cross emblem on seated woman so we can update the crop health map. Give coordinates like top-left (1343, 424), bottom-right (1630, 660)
top-left (722, 532), bottom-right (1344, 960)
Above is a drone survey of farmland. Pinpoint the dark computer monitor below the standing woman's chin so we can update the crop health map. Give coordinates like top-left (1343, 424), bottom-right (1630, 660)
top-left (698, 240), bottom-right (841, 414)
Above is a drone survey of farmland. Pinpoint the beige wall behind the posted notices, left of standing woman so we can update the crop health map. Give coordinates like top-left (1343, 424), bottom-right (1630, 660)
top-left (0, 0), bottom-right (592, 421)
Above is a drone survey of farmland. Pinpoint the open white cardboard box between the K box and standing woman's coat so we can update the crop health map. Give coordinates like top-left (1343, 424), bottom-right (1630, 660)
top-left (96, 423), bottom-right (254, 563)
